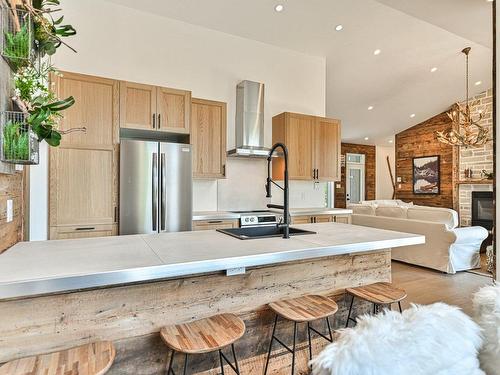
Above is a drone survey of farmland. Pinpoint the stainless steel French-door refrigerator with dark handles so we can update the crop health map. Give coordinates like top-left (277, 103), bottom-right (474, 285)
top-left (120, 139), bottom-right (193, 235)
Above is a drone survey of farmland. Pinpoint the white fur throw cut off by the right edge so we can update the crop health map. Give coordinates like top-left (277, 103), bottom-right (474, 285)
top-left (474, 284), bottom-right (500, 375)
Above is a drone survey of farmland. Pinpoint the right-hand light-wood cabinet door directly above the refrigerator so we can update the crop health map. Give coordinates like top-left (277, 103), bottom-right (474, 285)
top-left (157, 87), bottom-right (191, 134)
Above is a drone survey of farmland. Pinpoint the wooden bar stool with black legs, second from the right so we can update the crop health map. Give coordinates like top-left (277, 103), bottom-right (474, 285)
top-left (264, 295), bottom-right (338, 375)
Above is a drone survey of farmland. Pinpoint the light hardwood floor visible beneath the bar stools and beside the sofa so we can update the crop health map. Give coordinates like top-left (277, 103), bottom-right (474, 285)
top-left (195, 262), bottom-right (492, 375)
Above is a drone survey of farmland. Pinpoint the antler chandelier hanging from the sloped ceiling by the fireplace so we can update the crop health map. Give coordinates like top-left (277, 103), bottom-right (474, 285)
top-left (436, 47), bottom-right (490, 148)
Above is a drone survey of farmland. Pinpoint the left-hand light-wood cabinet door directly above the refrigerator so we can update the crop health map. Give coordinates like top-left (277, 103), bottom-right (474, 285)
top-left (120, 81), bottom-right (156, 130)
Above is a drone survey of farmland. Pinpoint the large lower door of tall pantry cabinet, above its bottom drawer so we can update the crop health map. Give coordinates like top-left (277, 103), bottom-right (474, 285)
top-left (50, 148), bottom-right (115, 226)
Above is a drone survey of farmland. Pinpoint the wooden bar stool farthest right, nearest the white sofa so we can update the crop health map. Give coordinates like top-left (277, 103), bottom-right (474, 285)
top-left (345, 283), bottom-right (407, 328)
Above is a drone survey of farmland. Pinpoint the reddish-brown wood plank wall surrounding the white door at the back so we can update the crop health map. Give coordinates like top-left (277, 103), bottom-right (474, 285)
top-left (335, 143), bottom-right (376, 208)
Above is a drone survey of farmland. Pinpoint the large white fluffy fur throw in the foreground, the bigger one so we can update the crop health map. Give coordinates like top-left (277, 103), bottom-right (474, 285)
top-left (311, 303), bottom-right (484, 375)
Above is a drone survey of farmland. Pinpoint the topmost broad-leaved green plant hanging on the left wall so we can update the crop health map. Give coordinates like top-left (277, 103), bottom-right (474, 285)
top-left (33, 0), bottom-right (76, 56)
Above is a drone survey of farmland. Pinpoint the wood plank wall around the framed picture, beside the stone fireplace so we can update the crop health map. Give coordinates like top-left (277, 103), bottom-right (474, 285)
top-left (396, 113), bottom-right (458, 208)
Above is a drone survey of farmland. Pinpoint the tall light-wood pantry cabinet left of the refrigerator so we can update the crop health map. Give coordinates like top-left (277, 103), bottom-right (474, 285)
top-left (49, 73), bottom-right (119, 239)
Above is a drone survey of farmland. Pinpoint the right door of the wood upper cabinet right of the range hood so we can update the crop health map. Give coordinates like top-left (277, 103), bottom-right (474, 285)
top-left (314, 118), bottom-right (340, 181)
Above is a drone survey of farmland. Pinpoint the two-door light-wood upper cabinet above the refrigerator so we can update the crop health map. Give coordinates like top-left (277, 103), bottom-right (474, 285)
top-left (120, 81), bottom-right (191, 134)
